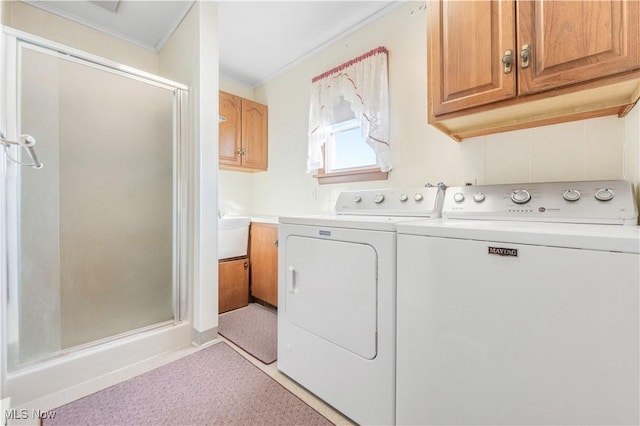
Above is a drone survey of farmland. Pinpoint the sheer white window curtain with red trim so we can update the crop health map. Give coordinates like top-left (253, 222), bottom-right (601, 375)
top-left (307, 47), bottom-right (392, 173)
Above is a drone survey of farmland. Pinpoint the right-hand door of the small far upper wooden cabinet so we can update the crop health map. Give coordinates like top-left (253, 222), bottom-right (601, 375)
top-left (242, 99), bottom-right (267, 170)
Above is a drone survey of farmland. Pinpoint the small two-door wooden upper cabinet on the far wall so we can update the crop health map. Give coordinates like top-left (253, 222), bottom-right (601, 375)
top-left (218, 92), bottom-right (268, 172)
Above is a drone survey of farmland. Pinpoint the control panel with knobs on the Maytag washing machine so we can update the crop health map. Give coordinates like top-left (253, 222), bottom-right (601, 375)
top-left (442, 180), bottom-right (638, 225)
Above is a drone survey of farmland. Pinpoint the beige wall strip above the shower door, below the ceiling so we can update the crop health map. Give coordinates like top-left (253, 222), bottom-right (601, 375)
top-left (2, 0), bottom-right (158, 74)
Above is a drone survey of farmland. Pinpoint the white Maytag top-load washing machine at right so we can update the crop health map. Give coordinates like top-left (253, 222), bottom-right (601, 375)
top-left (396, 181), bottom-right (640, 425)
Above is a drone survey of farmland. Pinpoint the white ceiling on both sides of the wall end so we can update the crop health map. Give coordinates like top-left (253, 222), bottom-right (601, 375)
top-left (22, 0), bottom-right (400, 87)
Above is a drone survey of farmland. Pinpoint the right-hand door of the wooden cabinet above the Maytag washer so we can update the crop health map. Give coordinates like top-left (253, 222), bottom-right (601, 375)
top-left (516, 0), bottom-right (640, 94)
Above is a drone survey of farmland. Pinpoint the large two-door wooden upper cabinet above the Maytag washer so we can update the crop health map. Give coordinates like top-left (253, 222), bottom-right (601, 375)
top-left (427, 0), bottom-right (640, 140)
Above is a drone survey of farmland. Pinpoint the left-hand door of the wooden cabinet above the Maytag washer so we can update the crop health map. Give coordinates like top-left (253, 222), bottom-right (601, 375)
top-left (427, 1), bottom-right (516, 116)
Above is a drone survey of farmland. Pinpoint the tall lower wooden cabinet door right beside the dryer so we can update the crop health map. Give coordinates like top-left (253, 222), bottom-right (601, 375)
top-left (250, 223), bottom-right (278, 306)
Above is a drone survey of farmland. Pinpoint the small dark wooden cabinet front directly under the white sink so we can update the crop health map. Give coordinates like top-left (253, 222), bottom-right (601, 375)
top-left (218, 257), bottom-right (249, 313)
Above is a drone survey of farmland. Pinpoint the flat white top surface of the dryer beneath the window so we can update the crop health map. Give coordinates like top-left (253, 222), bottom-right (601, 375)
top-left (280, 215), bottom-right (424, 232)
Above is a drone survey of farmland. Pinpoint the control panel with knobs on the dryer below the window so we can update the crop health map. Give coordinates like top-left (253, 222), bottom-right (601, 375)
top-left (336, 186), bottom-right (444, 217)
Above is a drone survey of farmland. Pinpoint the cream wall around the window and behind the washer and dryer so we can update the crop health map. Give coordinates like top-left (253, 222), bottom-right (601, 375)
top-left (244, 2), bottom-right (640, 215)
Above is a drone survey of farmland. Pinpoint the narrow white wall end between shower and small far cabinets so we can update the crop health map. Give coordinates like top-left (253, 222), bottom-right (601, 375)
top-left (159, 2), bottom-right (218, 343)
